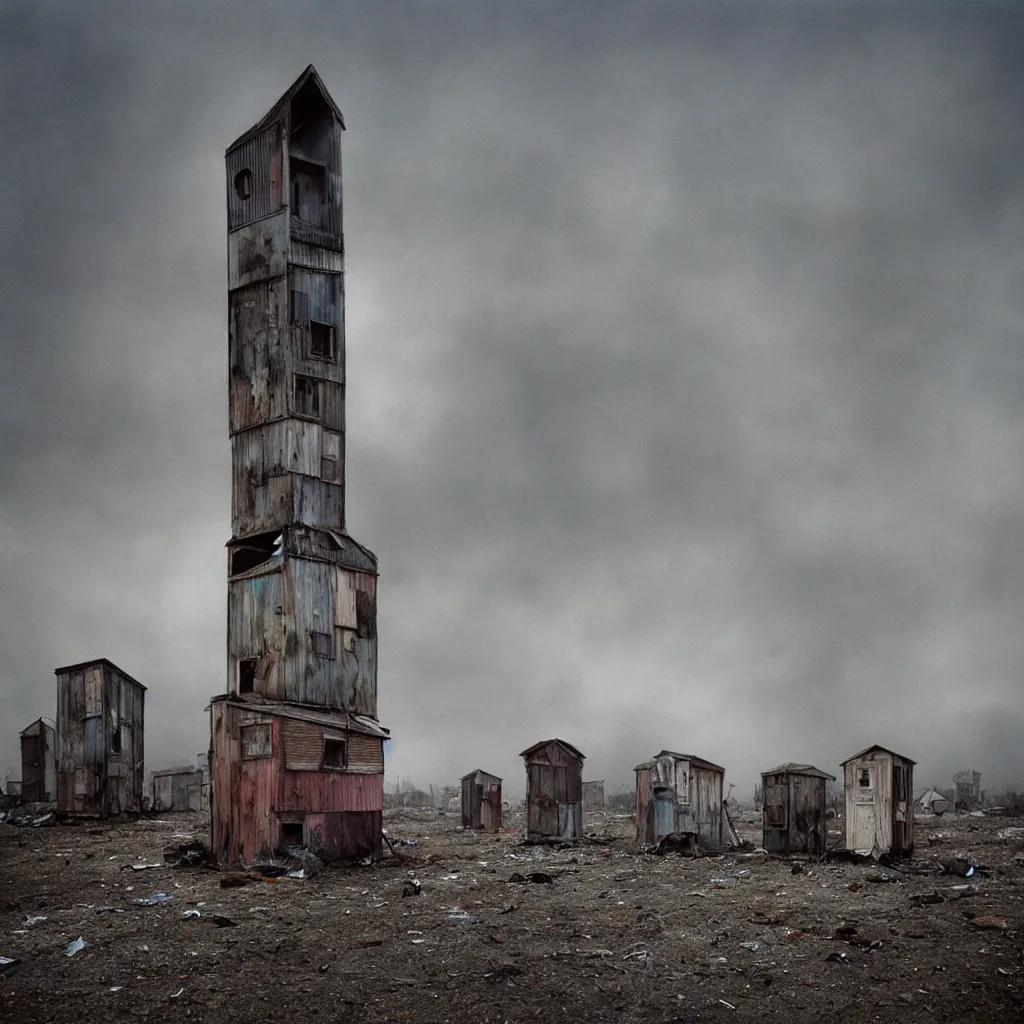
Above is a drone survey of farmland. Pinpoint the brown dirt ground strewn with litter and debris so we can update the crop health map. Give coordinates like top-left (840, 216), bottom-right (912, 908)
top-left (0, 811), bottom-right (1024, 1024)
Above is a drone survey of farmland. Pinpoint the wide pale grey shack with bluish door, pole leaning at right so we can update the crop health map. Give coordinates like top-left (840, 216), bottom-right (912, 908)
top-left (635, 751), bottom-right (725, 853)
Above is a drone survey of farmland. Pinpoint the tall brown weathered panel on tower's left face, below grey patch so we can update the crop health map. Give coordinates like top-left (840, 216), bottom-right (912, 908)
top-left (228, 279), bottom-right (288, 434)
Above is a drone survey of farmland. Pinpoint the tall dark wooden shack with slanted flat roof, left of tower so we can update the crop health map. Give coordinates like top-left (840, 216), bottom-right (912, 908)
top-left (56, 657), bottom-right (145, 818)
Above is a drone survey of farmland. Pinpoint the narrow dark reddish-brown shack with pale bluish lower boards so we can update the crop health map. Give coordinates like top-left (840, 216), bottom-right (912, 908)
top-left (519, 738), bottom-right (586, 843)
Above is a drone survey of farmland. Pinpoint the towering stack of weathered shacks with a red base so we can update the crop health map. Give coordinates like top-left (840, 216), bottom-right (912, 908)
top-left (210, 66), bottom-right (387, 862)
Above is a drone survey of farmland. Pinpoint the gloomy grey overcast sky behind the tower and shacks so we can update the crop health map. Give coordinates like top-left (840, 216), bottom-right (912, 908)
top-left (0, 0), bottom-right (1024, 793)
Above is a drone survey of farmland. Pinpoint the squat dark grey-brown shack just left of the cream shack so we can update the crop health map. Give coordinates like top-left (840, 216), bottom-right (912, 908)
top-left (761, 761), bottom-right (836, 857)
